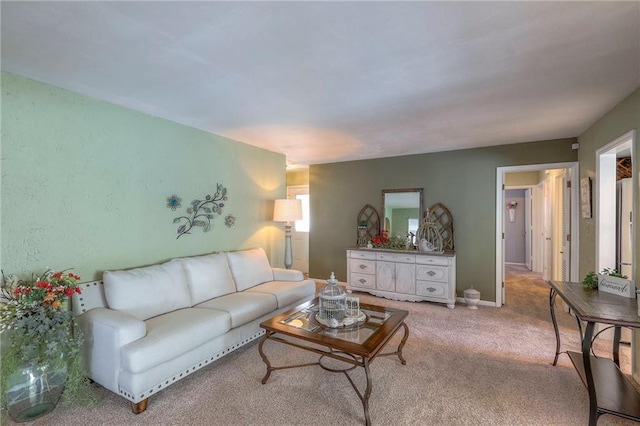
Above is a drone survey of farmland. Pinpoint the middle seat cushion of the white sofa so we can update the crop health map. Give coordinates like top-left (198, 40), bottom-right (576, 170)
top-left (194, 292), bottom-right (278, 328)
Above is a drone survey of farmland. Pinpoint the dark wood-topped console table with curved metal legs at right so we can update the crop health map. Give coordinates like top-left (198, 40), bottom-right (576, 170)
top-left (548, 281), bottom-right (640, 426)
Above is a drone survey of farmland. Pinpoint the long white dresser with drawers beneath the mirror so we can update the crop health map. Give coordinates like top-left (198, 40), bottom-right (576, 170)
top-left (347, 249), bottom-right (456, 309)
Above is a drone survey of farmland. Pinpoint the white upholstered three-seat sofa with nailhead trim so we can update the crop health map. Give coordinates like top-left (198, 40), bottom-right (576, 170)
top-left (73, 248), bottom-right (316, 414)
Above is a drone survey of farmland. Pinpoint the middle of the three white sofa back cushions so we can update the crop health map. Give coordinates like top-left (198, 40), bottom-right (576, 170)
top-left (175, 253), bottom-right (236, 305)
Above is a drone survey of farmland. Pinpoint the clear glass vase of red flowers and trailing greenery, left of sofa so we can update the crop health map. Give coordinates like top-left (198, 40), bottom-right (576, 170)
top-left (0, 270), bottom-right (93, 422)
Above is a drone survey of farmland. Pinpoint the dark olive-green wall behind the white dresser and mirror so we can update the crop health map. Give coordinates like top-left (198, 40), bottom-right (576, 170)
top-left (309, 138), bottom-right (577, 301)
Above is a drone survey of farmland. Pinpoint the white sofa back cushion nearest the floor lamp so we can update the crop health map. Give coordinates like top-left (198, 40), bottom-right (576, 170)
top-left (227, 247), bottom-right (273, 291)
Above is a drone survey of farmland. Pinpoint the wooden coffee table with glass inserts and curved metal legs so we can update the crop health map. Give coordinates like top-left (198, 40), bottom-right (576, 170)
top-left (258, 298), bottom-right (409, 426)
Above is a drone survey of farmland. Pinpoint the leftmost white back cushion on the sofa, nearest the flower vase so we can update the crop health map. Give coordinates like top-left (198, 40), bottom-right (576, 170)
top-left (103, 262), bottom-right (191, 320)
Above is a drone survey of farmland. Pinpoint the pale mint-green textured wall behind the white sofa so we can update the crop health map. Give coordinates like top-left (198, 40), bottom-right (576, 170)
top-left (0, 73), bottom-right (286, 281)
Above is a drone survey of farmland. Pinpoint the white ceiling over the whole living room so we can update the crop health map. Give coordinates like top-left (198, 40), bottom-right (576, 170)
top-left (1, 1), bottom-right (640, 164)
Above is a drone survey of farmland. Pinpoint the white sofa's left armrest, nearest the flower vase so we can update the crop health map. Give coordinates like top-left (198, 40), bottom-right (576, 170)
top-left (76, 308), bottom-right (147, 393)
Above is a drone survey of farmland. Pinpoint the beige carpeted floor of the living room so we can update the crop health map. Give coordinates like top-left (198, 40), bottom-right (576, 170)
top-left (2, 267), bottom-right (638, 426)
